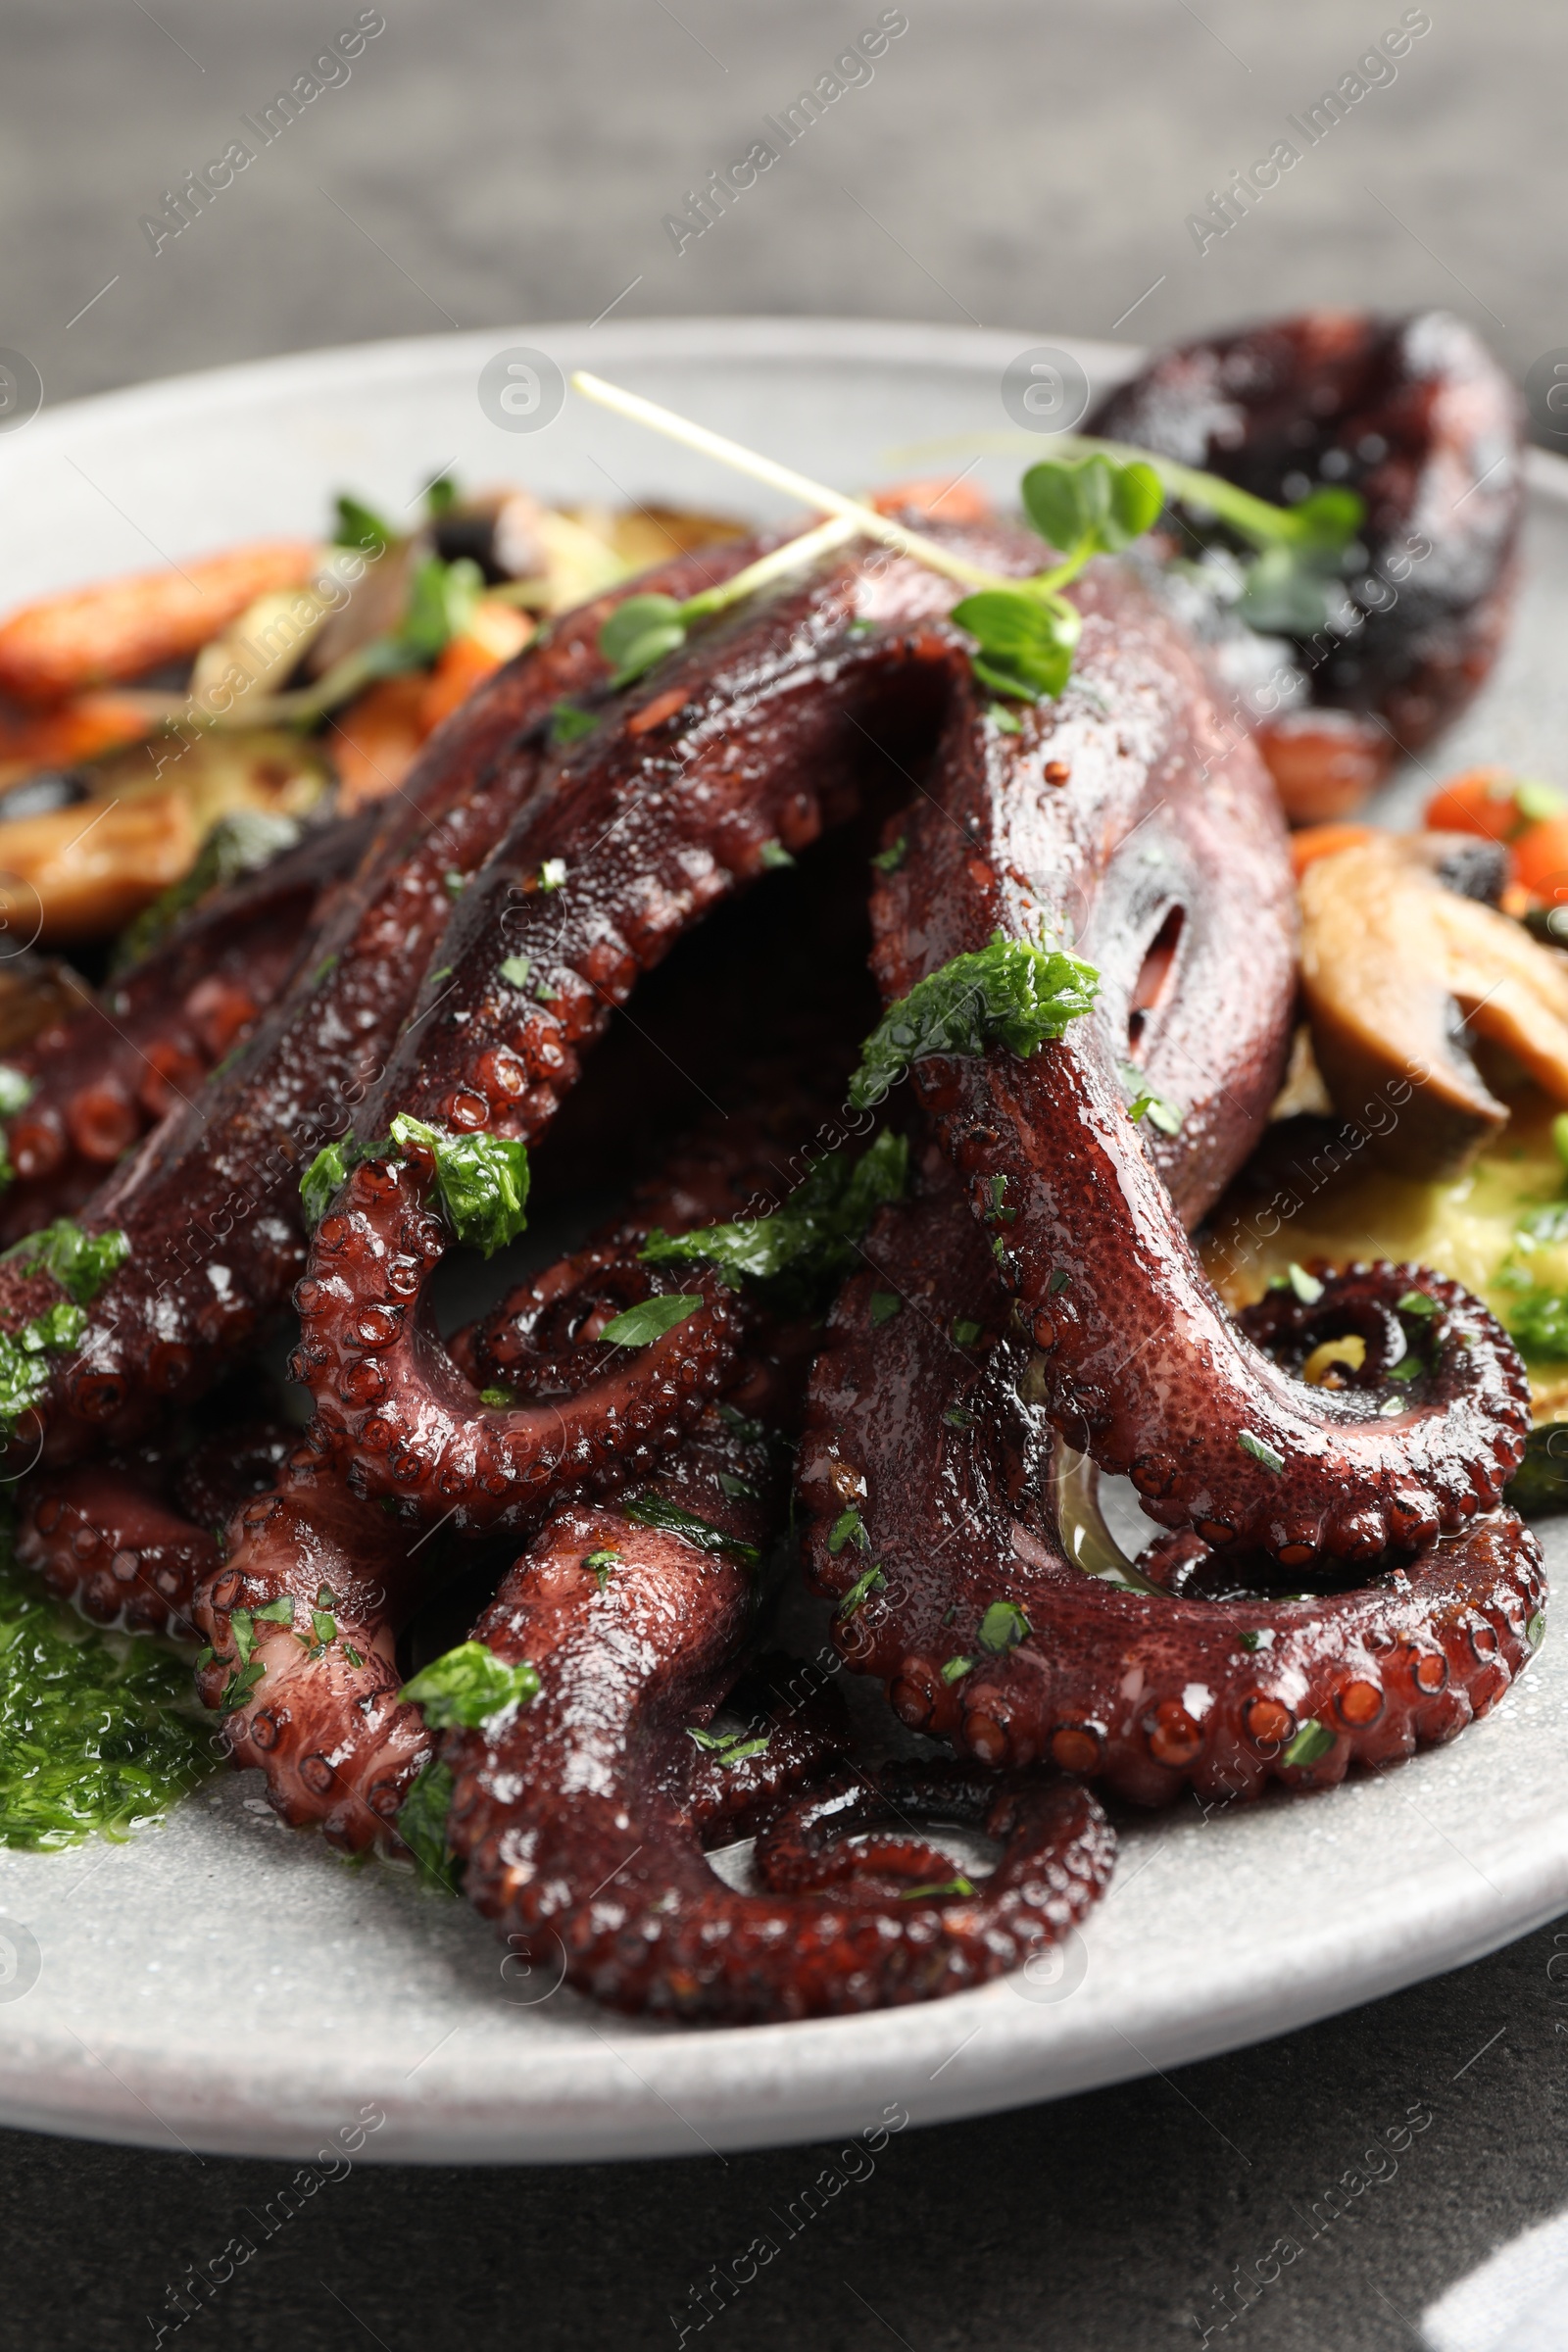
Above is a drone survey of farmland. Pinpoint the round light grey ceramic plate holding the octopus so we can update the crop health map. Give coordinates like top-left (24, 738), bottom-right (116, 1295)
top-left (0, 319), bottom-right (1568, 2162)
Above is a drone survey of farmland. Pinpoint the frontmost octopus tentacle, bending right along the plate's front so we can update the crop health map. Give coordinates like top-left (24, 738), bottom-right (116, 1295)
top-left (442, 1411), bottom-right (1114, 2023)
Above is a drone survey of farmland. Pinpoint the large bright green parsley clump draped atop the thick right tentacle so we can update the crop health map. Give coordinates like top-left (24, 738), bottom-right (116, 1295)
top-left (849, 931), bottom-right (1101, 1110)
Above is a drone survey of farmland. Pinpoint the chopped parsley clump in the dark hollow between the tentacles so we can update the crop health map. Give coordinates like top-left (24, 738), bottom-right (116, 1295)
top-left (642, 1131), bottom-right (909, 1298)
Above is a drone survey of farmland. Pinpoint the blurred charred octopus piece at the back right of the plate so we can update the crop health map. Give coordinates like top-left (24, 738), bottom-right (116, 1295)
top-left (1091, 311), bottom-right (1523, 764)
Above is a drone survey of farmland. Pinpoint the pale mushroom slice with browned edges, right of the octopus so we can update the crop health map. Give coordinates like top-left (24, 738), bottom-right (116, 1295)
top-left (1300, 833), bottom-right (1568, 1178)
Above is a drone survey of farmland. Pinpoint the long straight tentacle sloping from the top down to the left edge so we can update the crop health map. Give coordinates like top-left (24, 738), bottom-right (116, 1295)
top-left (0, 546), bottom-right (750, 1460)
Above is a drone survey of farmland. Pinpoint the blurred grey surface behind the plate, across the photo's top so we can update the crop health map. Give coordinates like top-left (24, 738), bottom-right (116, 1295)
top-left (0, 0), bottom-right (1568, 400)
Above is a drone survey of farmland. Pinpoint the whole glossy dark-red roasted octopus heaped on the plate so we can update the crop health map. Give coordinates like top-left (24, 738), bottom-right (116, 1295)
top-left (0, 318), bottom-right (1544, 2023)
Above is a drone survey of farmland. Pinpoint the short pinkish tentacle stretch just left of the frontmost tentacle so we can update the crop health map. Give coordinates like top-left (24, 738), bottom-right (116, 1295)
top-left (193, 1446), bottom-right (432, 1853)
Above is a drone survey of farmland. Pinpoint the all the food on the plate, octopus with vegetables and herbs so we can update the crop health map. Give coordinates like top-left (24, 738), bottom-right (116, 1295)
top-left (0, 313), bottom-right (1568, 2025)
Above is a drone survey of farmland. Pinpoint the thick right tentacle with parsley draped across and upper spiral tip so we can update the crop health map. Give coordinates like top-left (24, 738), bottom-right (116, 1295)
top-left (872, 597), bottom-right (1528, 1559)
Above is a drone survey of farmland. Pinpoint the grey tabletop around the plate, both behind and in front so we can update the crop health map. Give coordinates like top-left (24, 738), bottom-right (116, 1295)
top-left (0, 0), bottom-right (1568, 2352)
